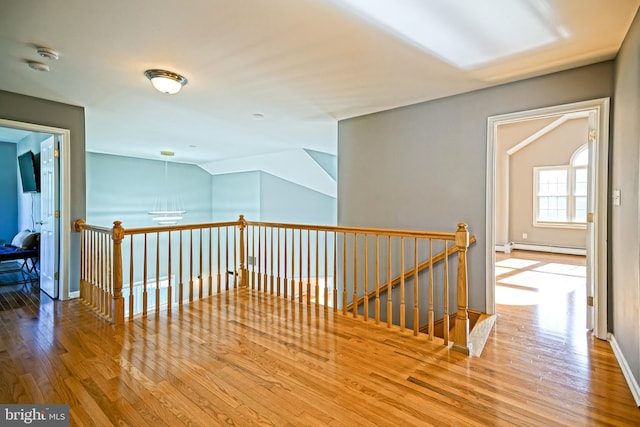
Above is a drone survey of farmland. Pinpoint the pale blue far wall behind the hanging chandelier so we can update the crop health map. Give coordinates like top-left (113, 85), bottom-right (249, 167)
top-left (87, 153), bottom-right (211, 228)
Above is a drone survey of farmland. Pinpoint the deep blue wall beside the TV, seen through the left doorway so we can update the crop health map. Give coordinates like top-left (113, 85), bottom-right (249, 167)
top-left (0, 142), bottom-right (20, 244)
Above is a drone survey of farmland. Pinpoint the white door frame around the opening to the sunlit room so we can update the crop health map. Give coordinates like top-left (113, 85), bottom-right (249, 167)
top-left (486, 98), bottom-right (610, 339)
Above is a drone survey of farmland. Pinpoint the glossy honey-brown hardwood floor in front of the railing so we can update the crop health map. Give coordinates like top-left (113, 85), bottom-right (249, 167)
top-left (0, 252), bottom-right (640, 426)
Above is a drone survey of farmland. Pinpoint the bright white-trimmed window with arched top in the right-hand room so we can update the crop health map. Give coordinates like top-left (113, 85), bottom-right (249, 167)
top-left (533, 145), bottom-right (589, 227)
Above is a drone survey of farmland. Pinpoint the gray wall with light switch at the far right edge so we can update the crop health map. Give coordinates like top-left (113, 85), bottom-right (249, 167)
top-left (609, 8), bottom-right (640, 394)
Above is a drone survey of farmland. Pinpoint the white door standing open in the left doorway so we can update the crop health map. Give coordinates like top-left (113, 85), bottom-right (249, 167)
top-left (40, 135), bottom-right (60, 298)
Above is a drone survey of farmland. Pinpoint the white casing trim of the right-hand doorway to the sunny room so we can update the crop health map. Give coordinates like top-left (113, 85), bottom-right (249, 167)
top-left (486, 98), bottom-right (609, 339)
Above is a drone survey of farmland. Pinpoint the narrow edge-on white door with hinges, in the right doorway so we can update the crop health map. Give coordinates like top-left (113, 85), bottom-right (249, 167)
top-left (586, 111), bottom-right (598, 329)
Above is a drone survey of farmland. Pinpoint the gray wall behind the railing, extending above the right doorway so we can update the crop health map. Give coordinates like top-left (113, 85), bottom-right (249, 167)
top-left (338, 61), bottom-right (613, 311)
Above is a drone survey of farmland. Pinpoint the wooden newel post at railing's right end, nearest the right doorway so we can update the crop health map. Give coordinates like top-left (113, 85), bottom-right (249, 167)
top-left (453, 223), bottom-right (469, 354)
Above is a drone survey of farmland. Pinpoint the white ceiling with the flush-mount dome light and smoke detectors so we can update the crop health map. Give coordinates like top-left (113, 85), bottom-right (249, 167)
top-left (0, 0), bottom-right (640, 170)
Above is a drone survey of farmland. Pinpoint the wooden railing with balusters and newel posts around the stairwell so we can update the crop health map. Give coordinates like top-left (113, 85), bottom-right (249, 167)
top-left (75, 215), bottom-right (476, 353)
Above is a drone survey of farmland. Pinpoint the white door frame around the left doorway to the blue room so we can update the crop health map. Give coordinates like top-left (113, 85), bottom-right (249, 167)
top-left (0, 119), bottom-right (71, 300)
